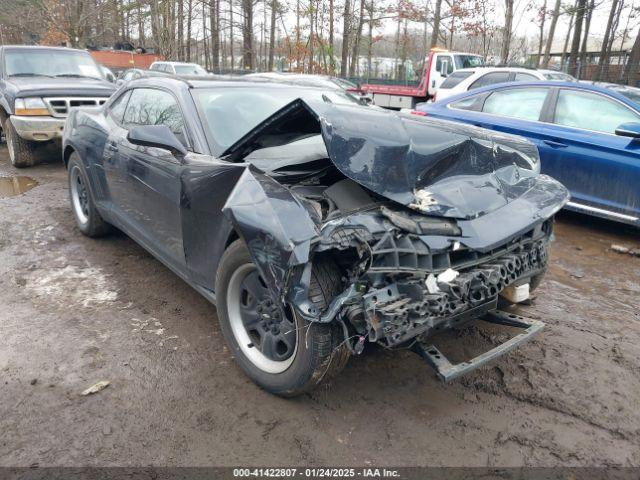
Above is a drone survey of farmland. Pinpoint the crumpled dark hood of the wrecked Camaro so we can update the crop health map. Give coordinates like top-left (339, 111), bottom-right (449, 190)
top-left (320, 106), bottom-right (540, 219)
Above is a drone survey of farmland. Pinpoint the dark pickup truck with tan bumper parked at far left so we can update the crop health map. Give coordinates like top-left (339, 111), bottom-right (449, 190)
top-left (0, 46), bottom-right (115, 168)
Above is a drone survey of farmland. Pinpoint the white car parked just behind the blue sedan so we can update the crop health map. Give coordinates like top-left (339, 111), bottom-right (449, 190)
top-left (433, 67), bottom-right (576, 102)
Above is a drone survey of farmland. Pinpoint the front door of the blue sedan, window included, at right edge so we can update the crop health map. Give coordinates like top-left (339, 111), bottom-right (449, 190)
top-left (543, 88), bottom-right (640, 220)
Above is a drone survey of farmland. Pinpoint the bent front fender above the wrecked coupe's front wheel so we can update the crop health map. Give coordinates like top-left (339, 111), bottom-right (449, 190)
top-left (222, 169), bottom-right (320, 298)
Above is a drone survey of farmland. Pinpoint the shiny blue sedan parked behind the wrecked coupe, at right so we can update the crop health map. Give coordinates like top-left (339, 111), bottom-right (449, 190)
top-left (415, 82), bottom-right (640, 226)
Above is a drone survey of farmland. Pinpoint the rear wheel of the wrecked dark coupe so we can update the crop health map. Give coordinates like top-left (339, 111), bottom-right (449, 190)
top-left (67, 152), bottom-right (111, 237)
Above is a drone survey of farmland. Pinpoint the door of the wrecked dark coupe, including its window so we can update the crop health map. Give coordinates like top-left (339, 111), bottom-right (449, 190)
top-left (118, 88), bottom-right (189, 268)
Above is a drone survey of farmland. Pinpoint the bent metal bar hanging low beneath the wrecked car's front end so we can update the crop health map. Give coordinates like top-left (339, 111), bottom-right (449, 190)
top-left (413, 310), bottom-right (545, 382)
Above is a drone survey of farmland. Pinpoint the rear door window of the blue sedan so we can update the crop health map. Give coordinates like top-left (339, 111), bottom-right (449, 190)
top-left (482, 88), bottom-right (549, 120)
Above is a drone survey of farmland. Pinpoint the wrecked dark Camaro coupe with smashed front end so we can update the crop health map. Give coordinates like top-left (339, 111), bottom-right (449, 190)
top-left (63, 78), bottom-right (568, 396)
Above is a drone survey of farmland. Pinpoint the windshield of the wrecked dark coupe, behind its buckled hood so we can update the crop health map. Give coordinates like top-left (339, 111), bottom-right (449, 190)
top-left (192, 87), bottom-right (367, 153)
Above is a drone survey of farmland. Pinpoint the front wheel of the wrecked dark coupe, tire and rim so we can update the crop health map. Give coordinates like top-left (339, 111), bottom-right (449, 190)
top-left (216, 240), bottom-right (350, 397)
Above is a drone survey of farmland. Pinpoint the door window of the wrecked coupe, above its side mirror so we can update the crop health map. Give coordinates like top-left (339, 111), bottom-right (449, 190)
top-left (124, 88), bottom-right (186, 141)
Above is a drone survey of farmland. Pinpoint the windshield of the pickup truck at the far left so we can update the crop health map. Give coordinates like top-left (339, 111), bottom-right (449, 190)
top-left (4, 48), bottom-right (104, 79)
